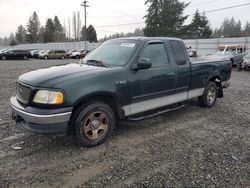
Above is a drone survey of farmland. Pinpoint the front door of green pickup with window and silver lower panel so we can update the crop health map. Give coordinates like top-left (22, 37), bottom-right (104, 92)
top-left (128, 42), bottom-right (176, 115)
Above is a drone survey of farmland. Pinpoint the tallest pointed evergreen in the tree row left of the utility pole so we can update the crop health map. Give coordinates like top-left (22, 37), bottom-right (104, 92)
top-left (27, 12), bottom-right (40, 43)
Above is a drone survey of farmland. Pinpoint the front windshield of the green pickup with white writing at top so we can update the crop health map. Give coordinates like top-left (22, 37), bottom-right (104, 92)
top-left (83, 39), bottom-right (139, 66)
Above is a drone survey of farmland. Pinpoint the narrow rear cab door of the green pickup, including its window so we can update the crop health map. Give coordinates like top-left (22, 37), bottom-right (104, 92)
top-left (169, 40), bottom-right (191, 96)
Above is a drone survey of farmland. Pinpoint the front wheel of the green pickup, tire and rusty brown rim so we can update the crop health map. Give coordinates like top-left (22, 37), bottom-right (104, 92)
top-left (74, 101), bottom-right (116, 147)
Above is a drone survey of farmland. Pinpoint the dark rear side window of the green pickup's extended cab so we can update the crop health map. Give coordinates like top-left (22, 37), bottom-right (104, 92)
top-left (169, 40), bottom-right (187, 65)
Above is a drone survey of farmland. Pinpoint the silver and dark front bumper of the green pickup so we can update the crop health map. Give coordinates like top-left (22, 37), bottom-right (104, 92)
top-left (10, 96), bottom-right (73, 135)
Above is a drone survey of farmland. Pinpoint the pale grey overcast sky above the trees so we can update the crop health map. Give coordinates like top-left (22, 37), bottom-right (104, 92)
top-left (0, 0), bottom-right (250, 38)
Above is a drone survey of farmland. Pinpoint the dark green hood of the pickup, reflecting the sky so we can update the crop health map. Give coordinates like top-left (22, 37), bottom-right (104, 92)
top-left (19, 64), bottom-right (112, 87)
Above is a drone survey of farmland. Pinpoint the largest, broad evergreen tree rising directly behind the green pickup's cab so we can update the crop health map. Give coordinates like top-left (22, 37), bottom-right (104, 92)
top-left (144, 0), bottom-right (189, 36)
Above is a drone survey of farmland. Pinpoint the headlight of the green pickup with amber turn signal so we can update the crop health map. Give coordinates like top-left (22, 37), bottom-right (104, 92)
top-left (33, 90), bottom-right (64, 104)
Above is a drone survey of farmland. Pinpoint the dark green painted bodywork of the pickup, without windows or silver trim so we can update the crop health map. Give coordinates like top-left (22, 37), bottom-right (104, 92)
top-left (19, 38), bottom-right (231, 113)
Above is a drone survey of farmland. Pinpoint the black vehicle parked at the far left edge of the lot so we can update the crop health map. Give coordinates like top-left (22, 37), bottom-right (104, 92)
top-left (0, 50), bottom-right (30, 60)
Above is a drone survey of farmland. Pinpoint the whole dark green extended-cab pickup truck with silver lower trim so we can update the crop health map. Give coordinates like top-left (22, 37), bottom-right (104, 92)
top-left (10, 37), bottom-right (232, 147)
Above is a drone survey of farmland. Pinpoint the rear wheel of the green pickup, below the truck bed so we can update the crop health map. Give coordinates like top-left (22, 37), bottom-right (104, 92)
top-left (198, 82), bottom-right (218, 107)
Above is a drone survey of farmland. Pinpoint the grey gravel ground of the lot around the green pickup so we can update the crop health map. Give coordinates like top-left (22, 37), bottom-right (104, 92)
top-left (0, 60), bottom-right (250, 188)
